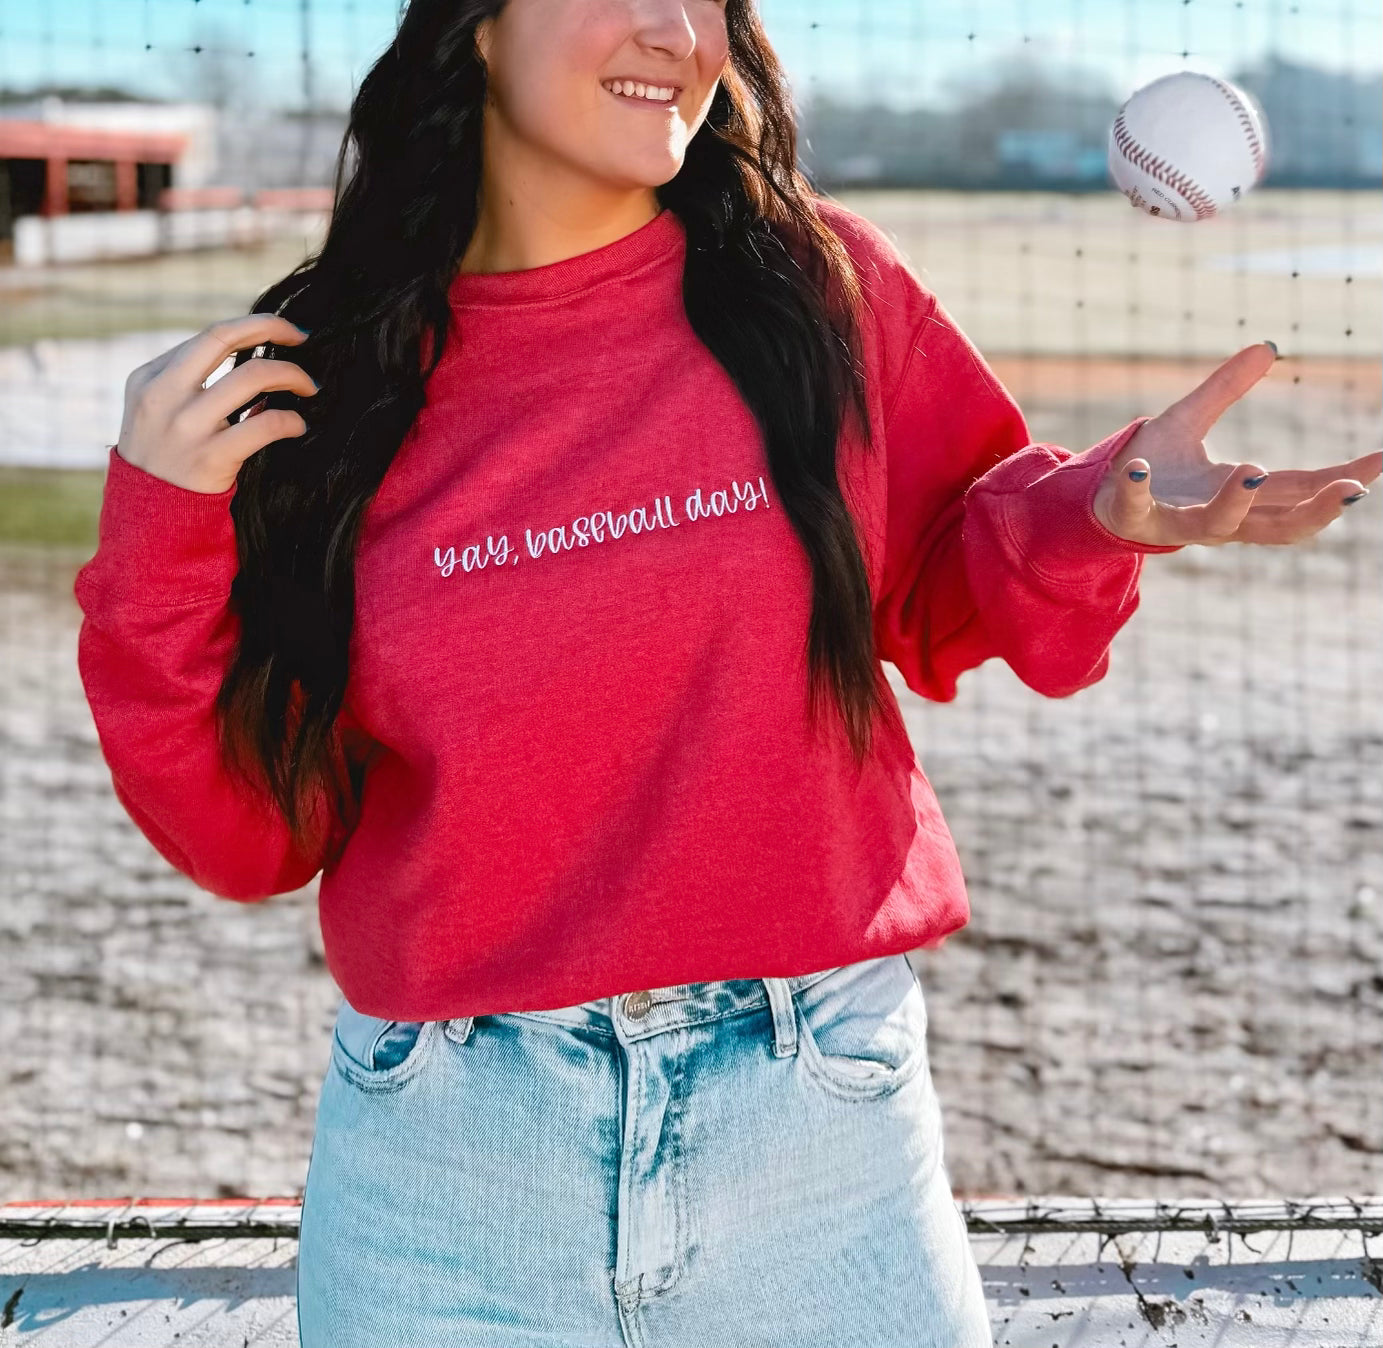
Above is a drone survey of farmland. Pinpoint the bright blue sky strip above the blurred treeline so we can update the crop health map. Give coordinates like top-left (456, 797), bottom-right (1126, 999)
top-left (0, 0), bottom-right (1383, 108)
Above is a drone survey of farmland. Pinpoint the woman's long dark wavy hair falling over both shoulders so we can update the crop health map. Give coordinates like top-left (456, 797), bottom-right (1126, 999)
top-left (216, 0), bottom-right (885, 865)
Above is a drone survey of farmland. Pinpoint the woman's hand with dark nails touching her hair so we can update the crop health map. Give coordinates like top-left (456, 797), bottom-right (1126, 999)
top-left (118, 314), bottom-right (317, 492)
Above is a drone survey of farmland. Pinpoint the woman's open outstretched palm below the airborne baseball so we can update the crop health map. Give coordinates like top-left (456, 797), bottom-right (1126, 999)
top-left (1094, 341), bottom-right (1383, 546)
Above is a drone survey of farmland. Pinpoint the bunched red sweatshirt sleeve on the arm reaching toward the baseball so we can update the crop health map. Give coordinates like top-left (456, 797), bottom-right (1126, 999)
top-left (874, 290), bottom-right (1178, 701)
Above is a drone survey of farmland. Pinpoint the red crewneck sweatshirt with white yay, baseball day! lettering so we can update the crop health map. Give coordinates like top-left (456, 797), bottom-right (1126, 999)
top-left (75, 200), bottom-right (1174, 1020)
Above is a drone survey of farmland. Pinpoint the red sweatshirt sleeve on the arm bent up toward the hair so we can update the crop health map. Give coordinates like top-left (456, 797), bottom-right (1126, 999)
top-left (73, 445), bottom-right (360, 900)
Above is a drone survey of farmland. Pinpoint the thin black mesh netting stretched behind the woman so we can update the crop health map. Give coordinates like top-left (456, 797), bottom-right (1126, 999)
top-left (0, 0), bottom-right (1383, 1199)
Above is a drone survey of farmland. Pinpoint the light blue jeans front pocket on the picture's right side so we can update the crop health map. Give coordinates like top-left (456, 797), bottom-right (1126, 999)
top-left (792, 954), bottom-right (927, 1101)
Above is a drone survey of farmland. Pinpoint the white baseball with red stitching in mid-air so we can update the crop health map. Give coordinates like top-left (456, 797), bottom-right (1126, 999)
top-left (1109, 71), bottom-right (1268, 221)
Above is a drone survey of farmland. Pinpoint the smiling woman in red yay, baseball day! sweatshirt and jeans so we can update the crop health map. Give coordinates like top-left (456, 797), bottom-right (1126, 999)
top-left (76, 0), bottom-right (1380, 1348)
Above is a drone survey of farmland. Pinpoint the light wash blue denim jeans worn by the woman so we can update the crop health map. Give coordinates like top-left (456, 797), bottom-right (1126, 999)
top-left (297, 954), bottom-right (993, 1348)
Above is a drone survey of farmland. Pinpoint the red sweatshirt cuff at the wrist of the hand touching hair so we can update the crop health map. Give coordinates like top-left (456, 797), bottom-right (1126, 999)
top-left (87, 445), bottom-right (239, 606)
